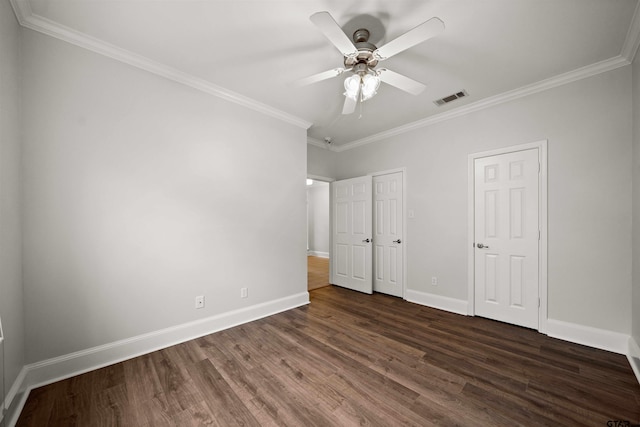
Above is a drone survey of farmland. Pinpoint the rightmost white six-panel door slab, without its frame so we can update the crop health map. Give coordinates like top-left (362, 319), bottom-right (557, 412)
top-left (474, 148), bottom-right (540, 329)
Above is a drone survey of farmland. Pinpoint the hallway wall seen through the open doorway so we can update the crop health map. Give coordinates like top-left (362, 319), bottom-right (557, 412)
top-left (307, 182), bottom-right (330, 256)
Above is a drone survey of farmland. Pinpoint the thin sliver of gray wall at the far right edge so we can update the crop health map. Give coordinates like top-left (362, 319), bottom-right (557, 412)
top-left (632, 54), bottom-right (640, 344)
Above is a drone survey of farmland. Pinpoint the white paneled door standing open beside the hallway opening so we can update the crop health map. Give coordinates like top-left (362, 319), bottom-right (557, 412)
top-left (331, 176), bottom-right (373, 294)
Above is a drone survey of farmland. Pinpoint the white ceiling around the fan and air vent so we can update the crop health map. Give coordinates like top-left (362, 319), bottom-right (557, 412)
top-left (12, 0), bottom-right (640, 148)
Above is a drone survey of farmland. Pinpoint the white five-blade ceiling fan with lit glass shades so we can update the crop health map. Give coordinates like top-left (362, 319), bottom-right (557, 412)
top-left (297, 12), bottom-right (444, 114)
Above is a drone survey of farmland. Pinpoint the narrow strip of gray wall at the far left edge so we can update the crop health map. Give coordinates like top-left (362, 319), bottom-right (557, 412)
top-left (0, 0), bottom-right (25, 414)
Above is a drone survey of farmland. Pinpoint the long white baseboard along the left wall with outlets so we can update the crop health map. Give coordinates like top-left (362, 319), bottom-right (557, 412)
top-left (6, 292), bottom-right (309, 426)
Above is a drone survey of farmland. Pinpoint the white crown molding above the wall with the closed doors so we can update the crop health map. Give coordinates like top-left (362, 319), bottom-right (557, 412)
top-left (334, 55), bottom-right (631, 152)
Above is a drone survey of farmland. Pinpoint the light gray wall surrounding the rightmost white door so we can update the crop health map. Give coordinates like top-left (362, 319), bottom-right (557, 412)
top-left (320, 66), bottom-right (632, 334)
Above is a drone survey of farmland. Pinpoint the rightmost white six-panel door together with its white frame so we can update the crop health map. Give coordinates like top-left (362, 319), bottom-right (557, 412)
top-left (468, 141), bottom-right (547, 332)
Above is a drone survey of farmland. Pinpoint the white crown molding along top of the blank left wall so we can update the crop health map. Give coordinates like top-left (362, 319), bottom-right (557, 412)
top-left (10, 0), bottom-right (312, 129)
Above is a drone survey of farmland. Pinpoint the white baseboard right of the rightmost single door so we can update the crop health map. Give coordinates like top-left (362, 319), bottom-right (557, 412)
top-left (547, 319), bottom-right (629, 354)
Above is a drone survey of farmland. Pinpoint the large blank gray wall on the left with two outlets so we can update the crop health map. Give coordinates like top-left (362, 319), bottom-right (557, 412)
top-left (22, 30), bottom-right (306, 362)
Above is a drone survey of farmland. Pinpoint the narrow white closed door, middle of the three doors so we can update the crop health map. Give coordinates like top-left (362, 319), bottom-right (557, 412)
top-left (373, 172), bottom-right (404, 297)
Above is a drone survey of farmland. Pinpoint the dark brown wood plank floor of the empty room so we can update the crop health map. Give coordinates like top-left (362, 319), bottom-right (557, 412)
top-left (18, 286), bottom-right (640, 427)
